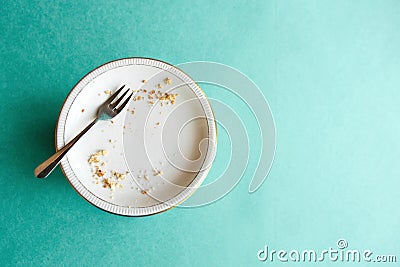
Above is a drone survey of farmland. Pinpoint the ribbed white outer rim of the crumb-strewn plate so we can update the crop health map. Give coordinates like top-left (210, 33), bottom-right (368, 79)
top-left (54, 57), bottom-right (218, 217)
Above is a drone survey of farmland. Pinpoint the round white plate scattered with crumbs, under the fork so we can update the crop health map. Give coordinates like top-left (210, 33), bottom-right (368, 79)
top-left (56, 58), bottom-right (216, 216)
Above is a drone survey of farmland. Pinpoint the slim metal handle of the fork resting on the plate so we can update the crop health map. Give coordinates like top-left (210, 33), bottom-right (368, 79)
top-left (34, 119), bottom-right (97, 178)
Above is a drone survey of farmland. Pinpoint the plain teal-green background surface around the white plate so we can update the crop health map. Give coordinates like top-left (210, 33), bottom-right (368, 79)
top-left (0, 0), bottom-right (400, 266)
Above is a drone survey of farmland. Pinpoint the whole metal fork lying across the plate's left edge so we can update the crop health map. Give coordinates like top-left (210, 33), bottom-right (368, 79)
top-left (34, 85), bottom-right (133, 178)
